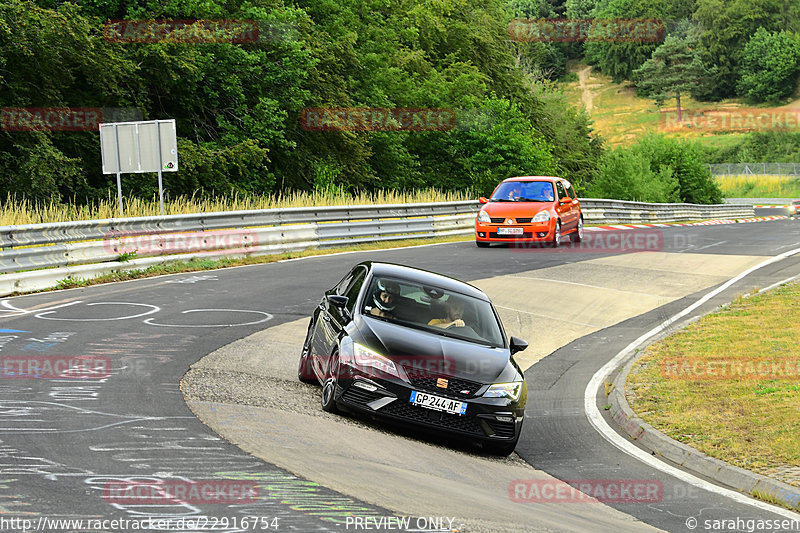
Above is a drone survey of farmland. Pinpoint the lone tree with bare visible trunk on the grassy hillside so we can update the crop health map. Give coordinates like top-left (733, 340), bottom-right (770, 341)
top-left (633, 36), bottom-right (708, 122)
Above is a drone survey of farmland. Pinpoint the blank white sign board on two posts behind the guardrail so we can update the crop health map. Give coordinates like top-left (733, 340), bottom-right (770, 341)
top-left (100, 119), bottom-right (178, 216)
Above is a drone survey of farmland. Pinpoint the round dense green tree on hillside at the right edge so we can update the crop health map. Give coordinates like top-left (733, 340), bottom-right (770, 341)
top-left (738, 28), bottom-right (800, 102)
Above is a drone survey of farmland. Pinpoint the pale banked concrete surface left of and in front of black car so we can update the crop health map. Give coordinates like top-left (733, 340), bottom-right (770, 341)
top-left (181, 319), bottom-right (655, 532)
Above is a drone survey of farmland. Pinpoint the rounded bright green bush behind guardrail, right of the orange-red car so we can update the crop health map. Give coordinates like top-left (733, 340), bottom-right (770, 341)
top-left (589, 134), bottom-right (722, 204)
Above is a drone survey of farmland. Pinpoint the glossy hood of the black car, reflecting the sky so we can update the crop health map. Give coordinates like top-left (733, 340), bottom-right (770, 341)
top-left (353, 316), bottom-right (521, 383)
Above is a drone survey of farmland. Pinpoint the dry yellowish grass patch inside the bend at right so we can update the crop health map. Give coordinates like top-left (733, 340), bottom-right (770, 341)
top-left (627, 283), bottom-right (800, 486)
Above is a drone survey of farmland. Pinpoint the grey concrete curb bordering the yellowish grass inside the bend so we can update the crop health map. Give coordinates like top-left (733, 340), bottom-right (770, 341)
top-left (608, 330), bottom-right (800, 511)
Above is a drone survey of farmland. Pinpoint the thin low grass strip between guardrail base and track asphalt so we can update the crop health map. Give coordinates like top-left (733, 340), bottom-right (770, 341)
top-left (25, 235), bottom-right (474, 296)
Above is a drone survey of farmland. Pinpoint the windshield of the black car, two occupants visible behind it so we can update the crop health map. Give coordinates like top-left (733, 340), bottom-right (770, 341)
top-left (361, 276), bottom-right (503, 347)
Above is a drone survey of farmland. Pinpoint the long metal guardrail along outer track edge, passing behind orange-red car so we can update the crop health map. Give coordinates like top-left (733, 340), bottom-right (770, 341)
top-left (0, 198), bottom-right (754, 294)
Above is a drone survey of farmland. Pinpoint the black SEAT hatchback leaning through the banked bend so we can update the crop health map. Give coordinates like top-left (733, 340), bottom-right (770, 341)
top-left (298, 262), bottom-right (528, 455)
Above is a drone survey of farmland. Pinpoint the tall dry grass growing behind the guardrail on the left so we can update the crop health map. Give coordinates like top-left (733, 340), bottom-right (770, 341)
top-left (0, 189), bottom-right (475, 226)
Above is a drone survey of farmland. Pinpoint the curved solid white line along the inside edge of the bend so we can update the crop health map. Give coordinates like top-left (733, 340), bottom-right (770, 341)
top-left (583, 248), bottom-right (800, 520)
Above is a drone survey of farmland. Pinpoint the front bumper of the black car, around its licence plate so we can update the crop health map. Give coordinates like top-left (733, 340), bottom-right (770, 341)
top-left (336, 370), bottom-right (526, 442)
